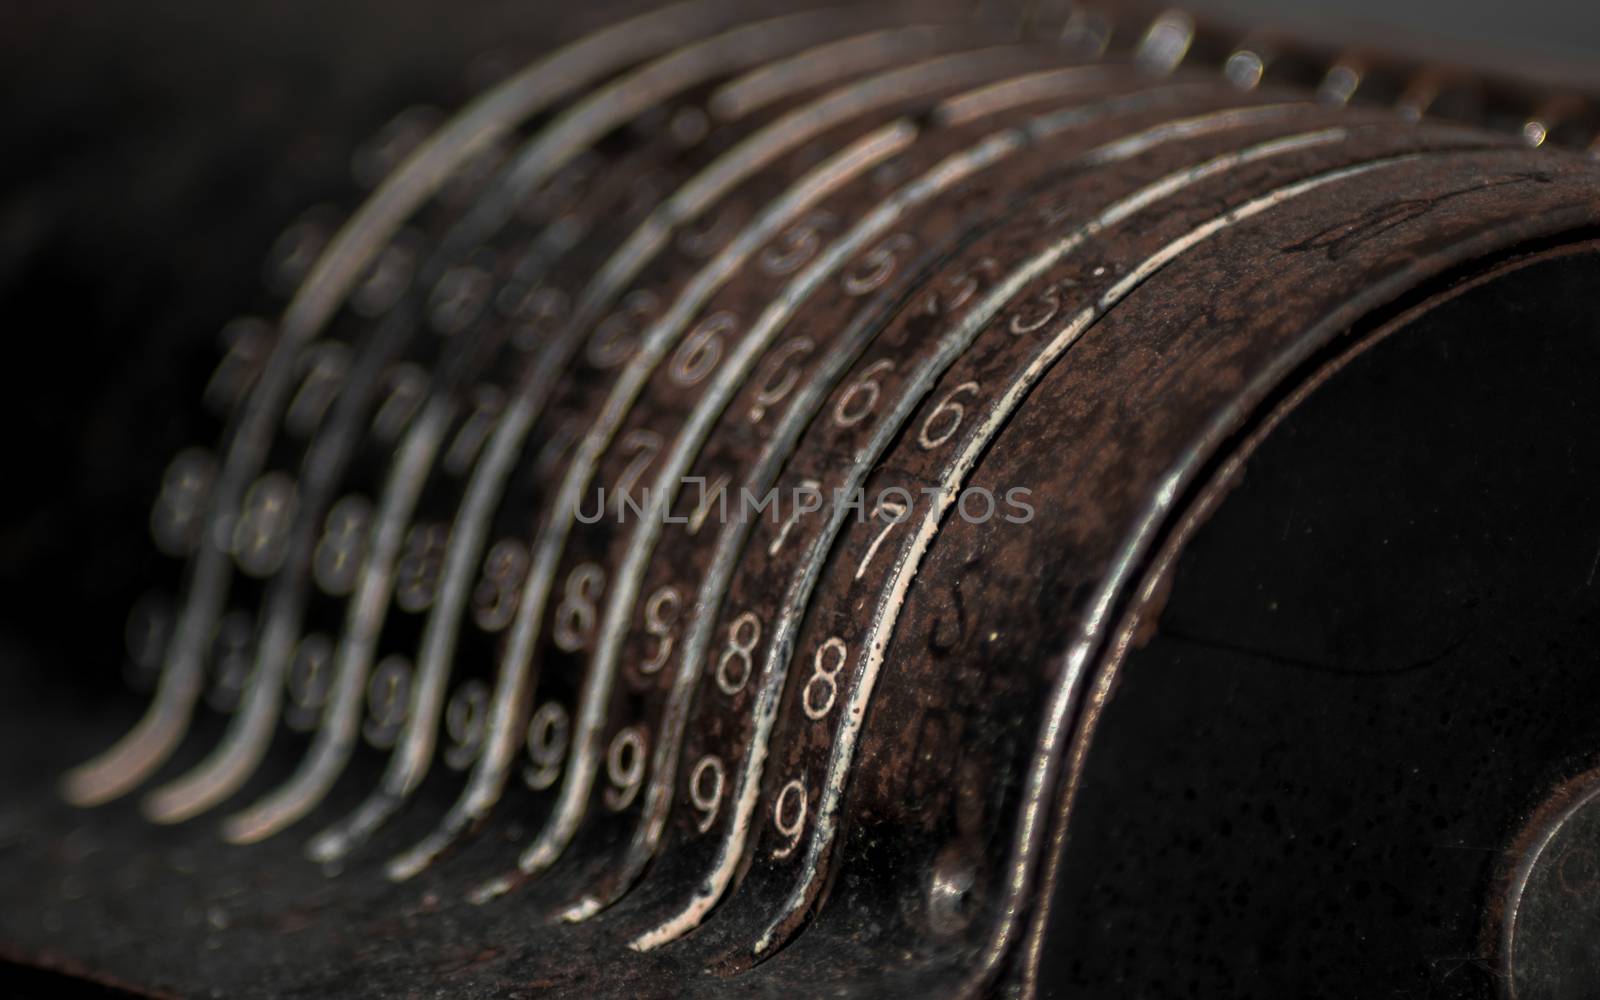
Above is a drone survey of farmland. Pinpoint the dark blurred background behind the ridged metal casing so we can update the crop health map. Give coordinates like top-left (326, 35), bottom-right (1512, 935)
top-left (0, 0), bottom-right (1600, 704)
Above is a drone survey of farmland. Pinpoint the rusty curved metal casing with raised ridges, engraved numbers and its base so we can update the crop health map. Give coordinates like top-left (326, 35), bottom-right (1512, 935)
top-left (0, 0), bottom-right (1600, 997)
